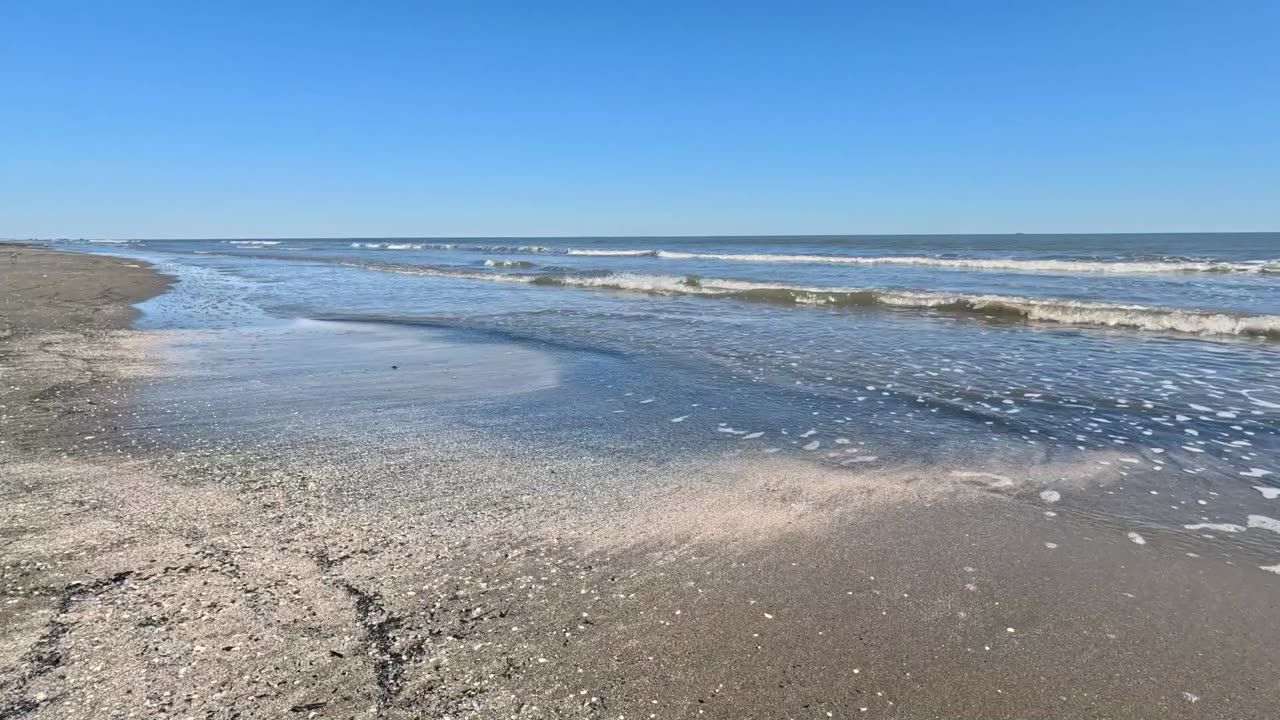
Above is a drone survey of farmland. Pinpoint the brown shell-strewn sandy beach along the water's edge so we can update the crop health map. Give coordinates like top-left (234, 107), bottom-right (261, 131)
top-left (0, 247), bottom-right (1280, 719)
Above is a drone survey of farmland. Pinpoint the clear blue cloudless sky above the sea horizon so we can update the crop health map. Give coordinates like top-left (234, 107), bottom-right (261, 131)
top-left (0, 0), bottom-right (1280, 237)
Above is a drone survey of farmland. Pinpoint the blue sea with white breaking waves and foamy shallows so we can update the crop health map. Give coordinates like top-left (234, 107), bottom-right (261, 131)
top-left (40, 233), bottom-right (1280, 525)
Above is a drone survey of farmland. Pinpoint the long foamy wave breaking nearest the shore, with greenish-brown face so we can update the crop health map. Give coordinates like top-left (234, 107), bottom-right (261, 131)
top-left (344, 263), bottom-right (1280, 340)
